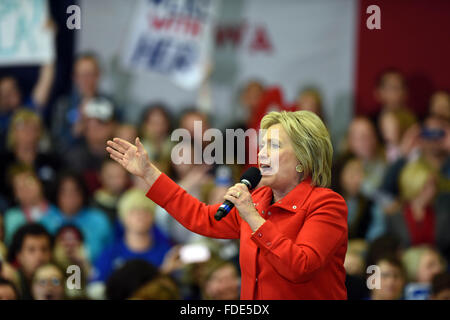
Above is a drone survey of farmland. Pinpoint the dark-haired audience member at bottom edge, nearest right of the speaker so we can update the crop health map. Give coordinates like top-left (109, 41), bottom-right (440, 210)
top-left (368, 256), bottom-right (406, 300)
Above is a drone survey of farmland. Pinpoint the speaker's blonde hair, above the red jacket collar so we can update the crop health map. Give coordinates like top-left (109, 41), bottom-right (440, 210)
top-left (261, 111), bottom-right (333, 187)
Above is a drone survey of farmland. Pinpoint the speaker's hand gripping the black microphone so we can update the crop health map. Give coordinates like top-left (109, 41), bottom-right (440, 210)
top-left (224, 183), bottom-right (266, 231)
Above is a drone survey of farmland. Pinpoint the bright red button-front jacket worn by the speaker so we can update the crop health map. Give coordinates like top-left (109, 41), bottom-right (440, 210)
top-left (147, 174), bottom-right (348, 300)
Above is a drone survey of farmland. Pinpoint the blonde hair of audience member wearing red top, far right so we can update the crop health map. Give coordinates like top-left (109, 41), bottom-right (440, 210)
top-left (399, 160), bottom-right (434, 201)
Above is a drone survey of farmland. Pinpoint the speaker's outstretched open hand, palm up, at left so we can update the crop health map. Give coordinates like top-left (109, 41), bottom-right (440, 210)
top-left (106, 138), bottom-right (161, 186)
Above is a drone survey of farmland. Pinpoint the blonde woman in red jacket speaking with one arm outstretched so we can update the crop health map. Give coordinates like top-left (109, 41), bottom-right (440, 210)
top-left (107, 111), bottom-right (347, 299)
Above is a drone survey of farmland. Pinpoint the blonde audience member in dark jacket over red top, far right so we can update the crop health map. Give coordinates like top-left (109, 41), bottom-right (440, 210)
top-left (387, 160), bottom-right (450, 253)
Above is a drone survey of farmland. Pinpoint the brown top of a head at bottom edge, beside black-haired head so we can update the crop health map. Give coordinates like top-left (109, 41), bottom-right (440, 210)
top-left (129, 275), bottom-right (181, 300)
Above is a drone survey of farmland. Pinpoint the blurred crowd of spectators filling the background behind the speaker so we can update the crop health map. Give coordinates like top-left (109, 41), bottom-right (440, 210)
top-left (0, 54), bottom-right (450, 300)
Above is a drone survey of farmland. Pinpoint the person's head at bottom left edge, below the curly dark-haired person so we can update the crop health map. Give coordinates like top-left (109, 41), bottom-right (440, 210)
top-left (31, 263), bottom-right (66, 300)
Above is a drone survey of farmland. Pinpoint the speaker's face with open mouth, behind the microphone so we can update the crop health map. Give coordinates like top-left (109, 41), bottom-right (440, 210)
top-left (258, 124), bottom-right (300, 191)
